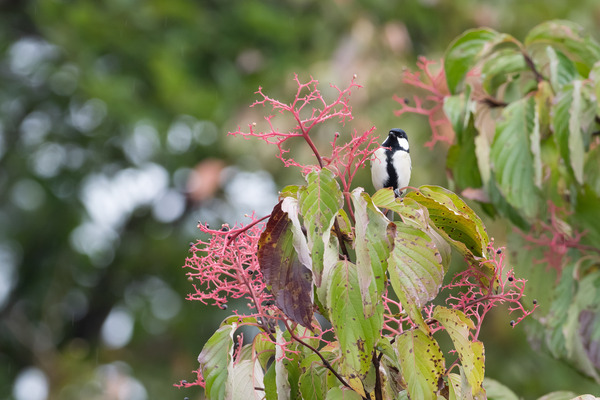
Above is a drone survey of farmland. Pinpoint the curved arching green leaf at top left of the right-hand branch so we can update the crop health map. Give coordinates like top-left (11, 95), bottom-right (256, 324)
top-left (444, 28), bottom-right (516, 94)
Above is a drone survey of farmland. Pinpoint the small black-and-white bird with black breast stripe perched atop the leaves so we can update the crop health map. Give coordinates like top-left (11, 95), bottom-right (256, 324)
top-left (371, 128), bottom-right (412, 197)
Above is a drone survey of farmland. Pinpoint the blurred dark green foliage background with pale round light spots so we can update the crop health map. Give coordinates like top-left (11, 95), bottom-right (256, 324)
top-left (0, 0), bottom-right (600, 400)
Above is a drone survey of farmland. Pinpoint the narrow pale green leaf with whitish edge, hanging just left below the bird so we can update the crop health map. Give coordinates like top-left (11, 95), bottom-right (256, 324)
top-left (352, 188), bottom-right (392, 317)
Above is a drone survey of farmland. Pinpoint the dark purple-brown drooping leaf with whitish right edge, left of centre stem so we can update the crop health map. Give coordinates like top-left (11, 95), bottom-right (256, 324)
top-left (258, 197), bottom-right (313, 327)
